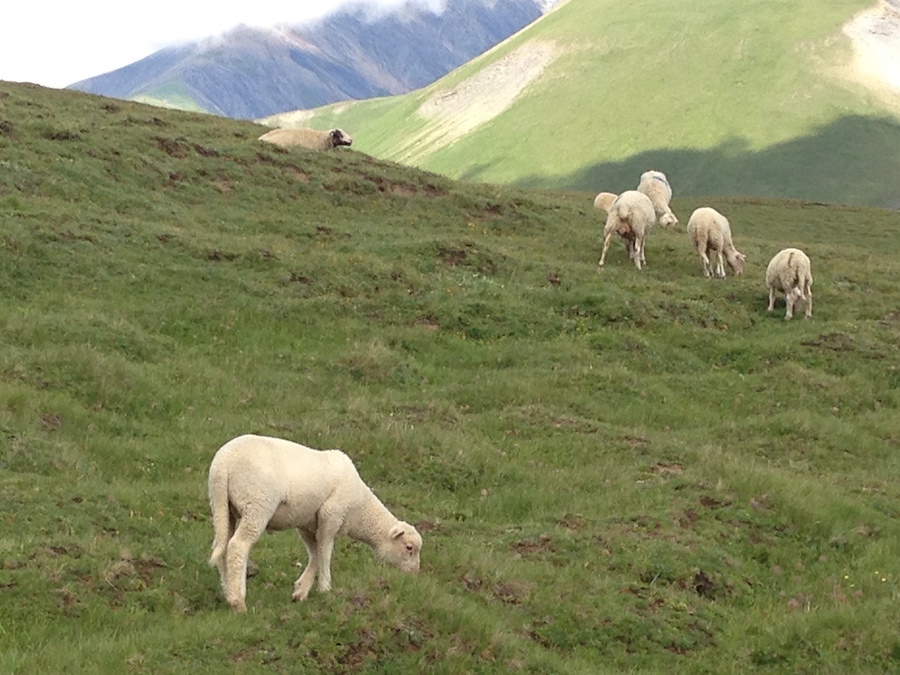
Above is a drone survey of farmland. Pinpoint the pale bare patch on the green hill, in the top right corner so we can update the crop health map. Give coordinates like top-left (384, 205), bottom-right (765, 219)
top-left (843, 0), bottom-right (900, 107)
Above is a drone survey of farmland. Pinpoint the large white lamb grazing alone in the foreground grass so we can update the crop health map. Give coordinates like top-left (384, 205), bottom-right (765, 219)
top-left (209, 434), bottom-right (422, 612)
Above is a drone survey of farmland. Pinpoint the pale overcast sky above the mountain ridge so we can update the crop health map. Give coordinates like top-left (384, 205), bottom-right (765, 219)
top-left (0, 0), bottom-right (443, 87)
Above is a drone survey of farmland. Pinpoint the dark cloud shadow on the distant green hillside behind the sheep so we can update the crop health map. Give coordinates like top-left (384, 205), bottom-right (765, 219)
top-left (512, 116), bottom-right (900, 209)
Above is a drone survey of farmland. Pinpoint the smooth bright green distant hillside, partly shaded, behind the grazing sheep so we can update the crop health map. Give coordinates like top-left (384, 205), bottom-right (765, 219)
top-left (270, 0), bottom-right (900, 207)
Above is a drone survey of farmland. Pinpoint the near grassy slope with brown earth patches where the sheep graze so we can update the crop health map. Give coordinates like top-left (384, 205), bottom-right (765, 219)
top-left (0, 83), bottom-right (900, 673)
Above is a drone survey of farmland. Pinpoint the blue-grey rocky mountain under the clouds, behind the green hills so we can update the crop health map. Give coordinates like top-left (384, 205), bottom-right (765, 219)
top-left (69, 0), bottom-right (552, 119)
